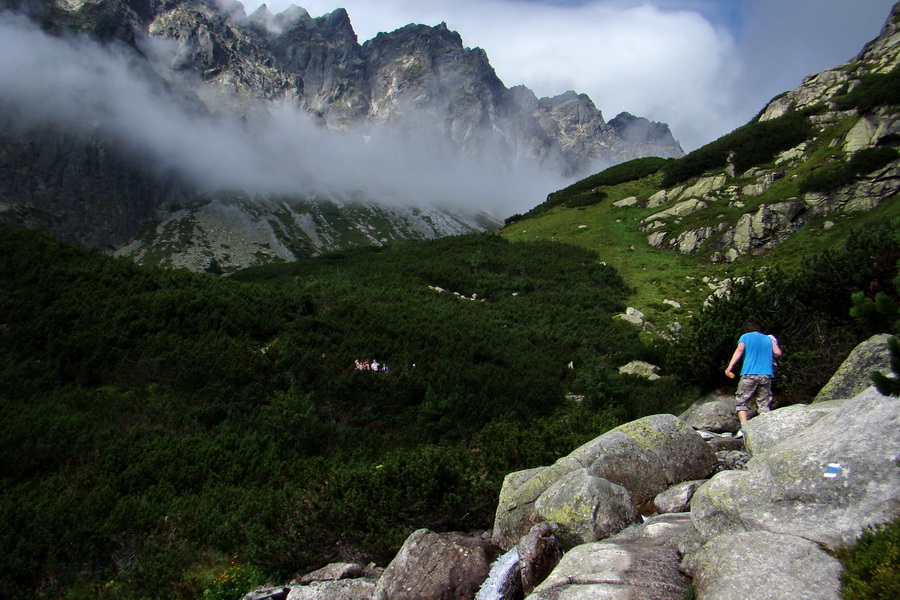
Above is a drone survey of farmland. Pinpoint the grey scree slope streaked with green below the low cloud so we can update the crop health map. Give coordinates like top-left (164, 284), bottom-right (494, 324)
top-left (114, 197), bottom-right (496, 272)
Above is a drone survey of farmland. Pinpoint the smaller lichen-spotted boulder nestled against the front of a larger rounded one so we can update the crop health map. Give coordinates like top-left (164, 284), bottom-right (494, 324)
top-left (535, 469), bottom-right (641, 549)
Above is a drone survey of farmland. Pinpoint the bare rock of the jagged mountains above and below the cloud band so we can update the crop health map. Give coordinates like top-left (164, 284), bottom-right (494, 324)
top-left (0, 0), bottom-right (683, 270)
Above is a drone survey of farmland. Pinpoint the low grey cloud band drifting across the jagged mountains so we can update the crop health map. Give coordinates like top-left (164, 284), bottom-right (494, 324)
top-left (0, 14), bottom-right (563, 218)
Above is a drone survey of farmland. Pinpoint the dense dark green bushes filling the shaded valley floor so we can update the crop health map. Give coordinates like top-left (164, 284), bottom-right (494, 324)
top-left (0, 227), bottom-right (643, 598)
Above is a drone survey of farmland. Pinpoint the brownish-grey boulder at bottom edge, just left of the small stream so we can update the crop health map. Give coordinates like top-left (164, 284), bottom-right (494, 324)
top-left (372, 529), bottom-right (497, 600)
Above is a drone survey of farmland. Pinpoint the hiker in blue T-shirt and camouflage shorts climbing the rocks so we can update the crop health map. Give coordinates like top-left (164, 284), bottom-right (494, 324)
top-left (725, 321), bottom-right (781, 437)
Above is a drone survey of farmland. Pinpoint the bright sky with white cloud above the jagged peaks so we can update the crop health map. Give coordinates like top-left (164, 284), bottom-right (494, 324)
top-left (244, 0), bottom-right (894, 151)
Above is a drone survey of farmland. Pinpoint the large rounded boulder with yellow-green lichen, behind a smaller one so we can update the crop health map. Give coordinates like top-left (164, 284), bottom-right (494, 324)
top-left (493, 415), bottom-right (717, 550)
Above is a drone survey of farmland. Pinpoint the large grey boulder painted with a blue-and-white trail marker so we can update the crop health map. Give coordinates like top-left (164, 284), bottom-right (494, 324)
top-left (691, 388), bottom-right (900, 548)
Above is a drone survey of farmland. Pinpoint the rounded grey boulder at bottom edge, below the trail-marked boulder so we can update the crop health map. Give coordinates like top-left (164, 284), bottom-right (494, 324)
top-left (682, 531), bottom-right (841, 600)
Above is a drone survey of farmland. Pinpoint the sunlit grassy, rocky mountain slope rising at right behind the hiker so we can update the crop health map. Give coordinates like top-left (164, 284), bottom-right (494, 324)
top-left (502, 0), bottom-right (900, 328)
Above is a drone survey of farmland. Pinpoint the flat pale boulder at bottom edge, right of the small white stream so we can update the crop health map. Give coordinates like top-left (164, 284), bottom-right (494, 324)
top-left (528, 515), bottom-right (693, 600)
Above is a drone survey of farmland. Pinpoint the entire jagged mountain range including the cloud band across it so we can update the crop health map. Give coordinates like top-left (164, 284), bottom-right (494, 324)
top-left (0, 0), bottom-right (683, 271)
